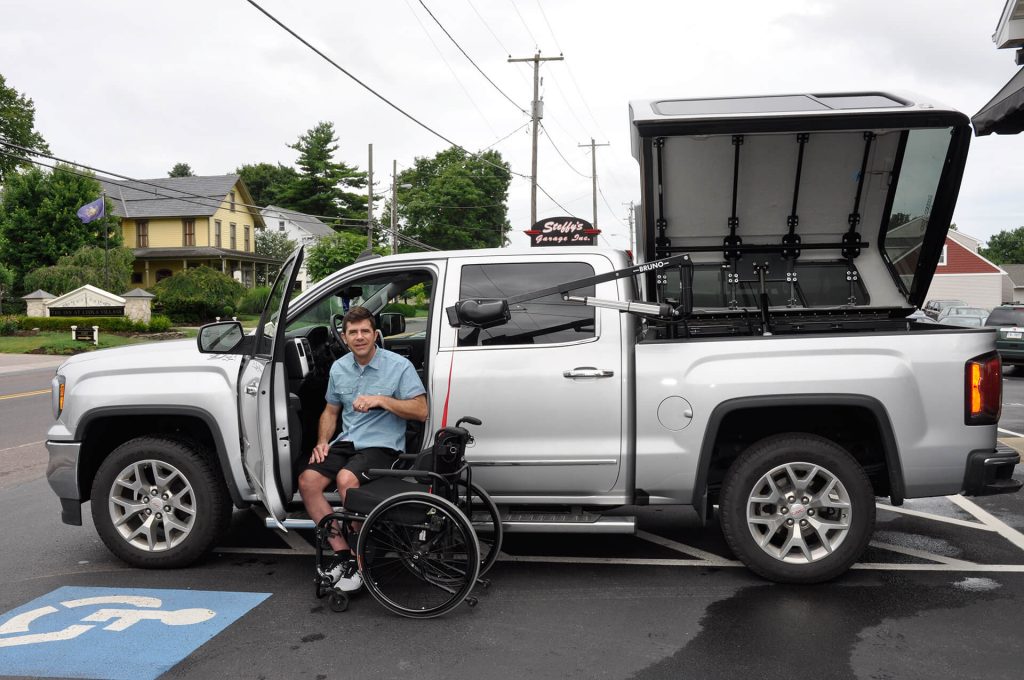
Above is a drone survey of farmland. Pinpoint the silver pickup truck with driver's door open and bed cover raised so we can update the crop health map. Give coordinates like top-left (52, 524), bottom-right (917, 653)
top-left (47, 93), bottom-right (1020, 583)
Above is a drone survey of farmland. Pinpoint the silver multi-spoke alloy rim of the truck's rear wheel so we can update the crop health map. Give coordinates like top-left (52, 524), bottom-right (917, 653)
top-left (746, 462), bottom-right (852, 564)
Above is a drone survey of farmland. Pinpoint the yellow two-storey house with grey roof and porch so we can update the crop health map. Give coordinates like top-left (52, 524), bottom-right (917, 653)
top-left (100, 175), bottom-right (281, 288)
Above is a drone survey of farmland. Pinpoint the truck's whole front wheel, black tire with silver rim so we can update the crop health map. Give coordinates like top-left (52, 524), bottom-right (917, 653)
top-left (90, 436), bottom-right (231, 569)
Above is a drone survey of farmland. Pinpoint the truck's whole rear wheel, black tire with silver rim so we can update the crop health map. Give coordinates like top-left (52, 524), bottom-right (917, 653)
top-left (719, 433), bottom-right (874, 584)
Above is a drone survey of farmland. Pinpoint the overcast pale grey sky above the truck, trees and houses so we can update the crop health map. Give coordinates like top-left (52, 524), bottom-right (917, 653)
top-left (0, 0), bottom-right (1024, 248)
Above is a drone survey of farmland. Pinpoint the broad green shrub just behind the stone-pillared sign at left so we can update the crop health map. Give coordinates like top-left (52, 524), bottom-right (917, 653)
top-left (24, 246), bottom-right (135, 296)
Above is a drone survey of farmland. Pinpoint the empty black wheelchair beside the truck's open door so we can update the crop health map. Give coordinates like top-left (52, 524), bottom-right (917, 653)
top-left (315, 417), bottom-right (503, 619)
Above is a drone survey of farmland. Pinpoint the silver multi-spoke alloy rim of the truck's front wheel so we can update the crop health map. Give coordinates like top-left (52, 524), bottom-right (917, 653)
top-left (108, 460), bottom-right (196, 552)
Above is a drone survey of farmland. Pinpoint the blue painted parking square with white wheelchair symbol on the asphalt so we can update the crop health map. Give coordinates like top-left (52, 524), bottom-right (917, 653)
top-left (0, 586), bottom-right (270, 680)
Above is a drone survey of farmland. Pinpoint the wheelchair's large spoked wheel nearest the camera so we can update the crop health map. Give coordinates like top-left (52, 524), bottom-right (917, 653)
top-left (355, 492), bottom-right (480, 619)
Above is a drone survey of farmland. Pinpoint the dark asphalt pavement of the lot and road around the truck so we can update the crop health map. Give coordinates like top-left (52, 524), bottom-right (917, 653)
top-left (0, 357), bottom-right (1024, 680)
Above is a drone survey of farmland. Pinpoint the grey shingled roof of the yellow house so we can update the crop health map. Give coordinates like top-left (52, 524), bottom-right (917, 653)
top-left (99, 175), bottom-right (248, 219)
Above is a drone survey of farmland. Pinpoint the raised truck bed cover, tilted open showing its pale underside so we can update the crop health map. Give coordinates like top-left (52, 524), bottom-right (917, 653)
top-left (630, 92), bottom-right (970, 316)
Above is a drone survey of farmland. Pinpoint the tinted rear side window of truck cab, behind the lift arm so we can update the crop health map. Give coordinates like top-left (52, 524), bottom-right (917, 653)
top-left (459, 262), bottom-right (595, 347)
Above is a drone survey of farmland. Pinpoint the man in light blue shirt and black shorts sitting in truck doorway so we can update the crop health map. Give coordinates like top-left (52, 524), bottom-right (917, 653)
top-left (299, 306), bottom-right (427, 591)
